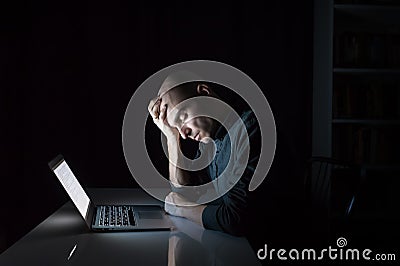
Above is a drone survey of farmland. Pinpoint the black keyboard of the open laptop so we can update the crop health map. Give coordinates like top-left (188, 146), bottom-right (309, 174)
top-left (98, 205), bottom-right (135, 227)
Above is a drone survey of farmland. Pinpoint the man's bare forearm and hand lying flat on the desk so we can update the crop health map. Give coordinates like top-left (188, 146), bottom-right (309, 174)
top-left (164, 192), bottom-right (206, 227)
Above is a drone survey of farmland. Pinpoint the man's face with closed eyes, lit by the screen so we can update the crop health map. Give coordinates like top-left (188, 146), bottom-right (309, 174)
top-left (161, 86), bottom-right (216, 142)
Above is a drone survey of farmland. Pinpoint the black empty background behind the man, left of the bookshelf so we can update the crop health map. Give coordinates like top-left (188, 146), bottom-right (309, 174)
top-left (0, 0), bottom-right (313, 252)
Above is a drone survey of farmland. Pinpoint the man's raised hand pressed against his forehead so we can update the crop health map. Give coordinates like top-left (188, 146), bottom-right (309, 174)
top-left (147, 97), bottom-right (179, 140)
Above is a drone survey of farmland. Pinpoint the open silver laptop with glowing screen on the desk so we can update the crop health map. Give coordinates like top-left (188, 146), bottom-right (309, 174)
top-left (49, 155), bottom-right (171, 232)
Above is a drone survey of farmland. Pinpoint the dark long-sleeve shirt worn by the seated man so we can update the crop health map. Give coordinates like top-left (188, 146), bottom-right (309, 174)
top-left (200, 111), bottom-right (261, 235)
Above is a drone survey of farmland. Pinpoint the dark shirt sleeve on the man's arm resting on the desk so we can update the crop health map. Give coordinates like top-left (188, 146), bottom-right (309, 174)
top-left (202, 112), bottom-right (261, 235)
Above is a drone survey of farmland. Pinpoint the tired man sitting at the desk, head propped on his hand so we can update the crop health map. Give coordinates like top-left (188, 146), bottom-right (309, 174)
top-left (148, 71), bottom-right (261, 235)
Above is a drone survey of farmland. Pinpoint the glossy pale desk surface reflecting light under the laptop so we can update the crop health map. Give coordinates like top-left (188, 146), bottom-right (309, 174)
top-left (0, 189), bottom-right (260, 266)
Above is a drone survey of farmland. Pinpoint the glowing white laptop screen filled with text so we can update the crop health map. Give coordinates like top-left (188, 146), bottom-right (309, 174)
top-left (54, 161), bottom-right (90, 218)
